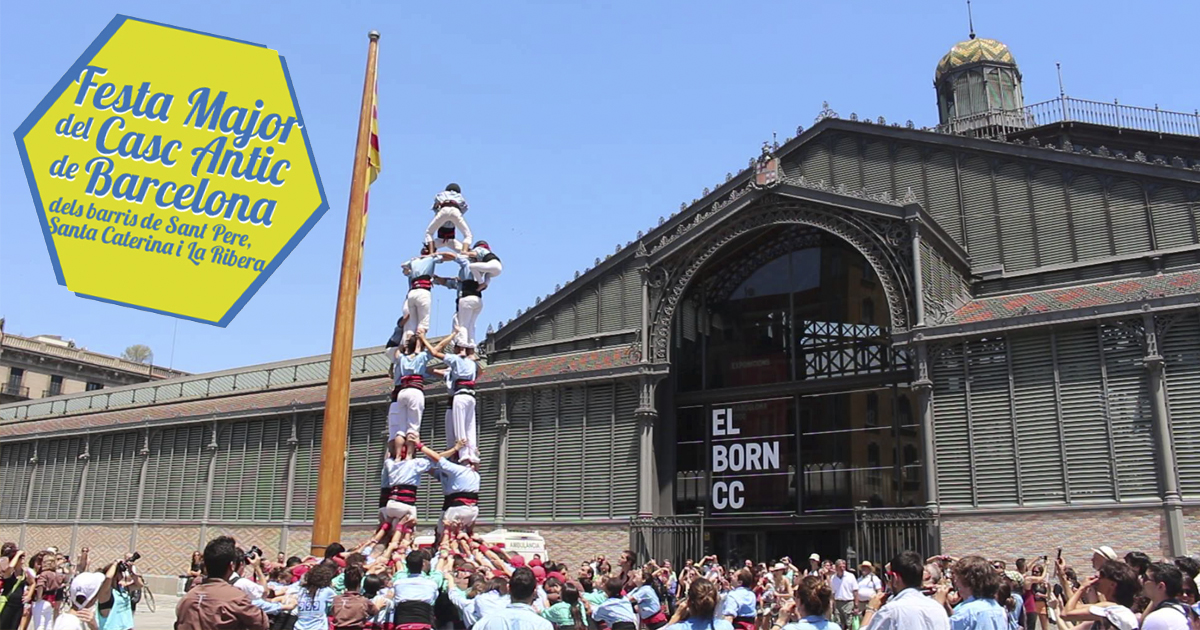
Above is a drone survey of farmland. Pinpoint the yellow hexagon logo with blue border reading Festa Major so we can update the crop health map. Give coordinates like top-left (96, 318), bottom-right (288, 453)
top-left (16, 16), bottom-right (329, 326)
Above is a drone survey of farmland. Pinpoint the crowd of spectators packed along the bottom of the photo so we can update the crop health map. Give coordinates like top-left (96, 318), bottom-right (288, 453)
top-left (0, 535), bottom-right (1200, 630)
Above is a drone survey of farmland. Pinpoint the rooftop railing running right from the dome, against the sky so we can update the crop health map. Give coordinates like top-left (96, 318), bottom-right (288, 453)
top-left (936, 96), bottom-right (1200, 137)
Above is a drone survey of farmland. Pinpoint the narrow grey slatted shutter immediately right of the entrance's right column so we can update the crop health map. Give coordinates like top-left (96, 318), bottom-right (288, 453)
top-left (931, 343), bottom-right (974, 505)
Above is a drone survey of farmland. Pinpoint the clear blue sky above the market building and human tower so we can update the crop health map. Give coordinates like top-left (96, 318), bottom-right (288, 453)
top-left (0, 0), bottom-right (1200, 372)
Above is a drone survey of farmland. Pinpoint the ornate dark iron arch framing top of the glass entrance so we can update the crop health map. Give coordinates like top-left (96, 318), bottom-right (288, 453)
top-left (649, 197), bottom-right (912, 361)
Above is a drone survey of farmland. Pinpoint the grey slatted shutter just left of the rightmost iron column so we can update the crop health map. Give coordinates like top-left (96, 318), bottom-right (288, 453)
top-left (1103, 324), bottom-right (1158, 499)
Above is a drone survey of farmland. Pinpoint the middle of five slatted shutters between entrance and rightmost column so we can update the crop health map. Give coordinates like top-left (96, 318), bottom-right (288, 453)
top-left (1009, 334), bottom-right (1066, 503)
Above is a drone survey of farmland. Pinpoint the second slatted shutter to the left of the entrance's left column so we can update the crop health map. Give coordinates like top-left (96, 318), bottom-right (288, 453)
top-left (583, 383), bottom-right (629, 518)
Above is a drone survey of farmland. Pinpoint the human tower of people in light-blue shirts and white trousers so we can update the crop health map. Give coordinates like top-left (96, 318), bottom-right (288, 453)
top-left (374, 184), bottom-right (502, 545)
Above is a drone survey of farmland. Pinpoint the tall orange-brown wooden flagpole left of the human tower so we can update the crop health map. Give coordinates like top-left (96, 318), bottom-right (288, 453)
top-left (312, 31), bottom-right (379, 557)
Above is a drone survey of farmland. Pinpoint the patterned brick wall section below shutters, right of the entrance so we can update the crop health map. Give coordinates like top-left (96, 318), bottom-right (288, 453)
top-left (942, 508), bottom-right (1166, 566)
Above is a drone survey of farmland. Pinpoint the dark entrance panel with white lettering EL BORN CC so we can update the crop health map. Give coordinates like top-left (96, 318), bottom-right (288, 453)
top-left (709, 398), bottom-right (796, 515)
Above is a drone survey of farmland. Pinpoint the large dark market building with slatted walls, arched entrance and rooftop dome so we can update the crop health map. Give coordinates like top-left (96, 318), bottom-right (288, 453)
top-left (0, 31), bottom-right (1200, 575)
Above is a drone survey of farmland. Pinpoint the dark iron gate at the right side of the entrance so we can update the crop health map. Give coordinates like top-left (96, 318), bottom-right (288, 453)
top-left (854, 508), bottom-right (942, 563)
